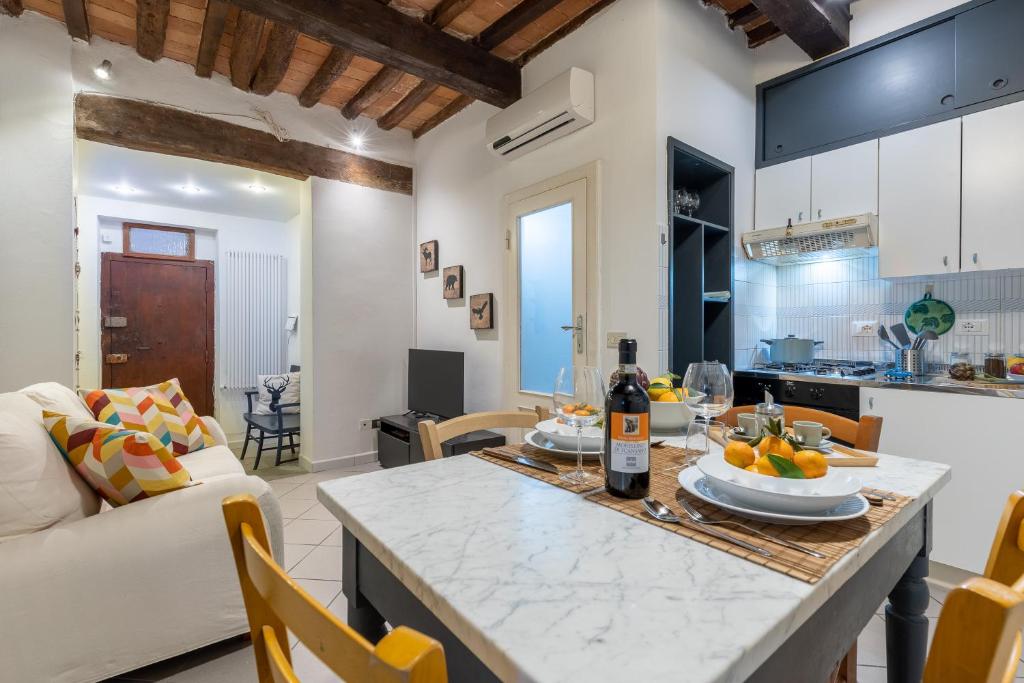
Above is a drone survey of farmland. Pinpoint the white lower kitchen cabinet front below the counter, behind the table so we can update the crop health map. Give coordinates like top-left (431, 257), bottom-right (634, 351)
top-left (860, 388), bottom-right (1024, 573)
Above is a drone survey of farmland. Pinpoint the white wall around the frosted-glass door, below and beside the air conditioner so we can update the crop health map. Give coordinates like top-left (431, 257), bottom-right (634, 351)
top-left (416, 0), bottom-right (655, 411)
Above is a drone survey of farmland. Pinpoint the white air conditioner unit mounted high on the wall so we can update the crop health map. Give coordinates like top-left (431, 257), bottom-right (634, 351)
top-left (487, 67), bottom-right (594, 159)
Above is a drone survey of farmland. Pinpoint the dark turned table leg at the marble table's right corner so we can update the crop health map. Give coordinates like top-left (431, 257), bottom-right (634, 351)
top-left (886, 506), bottom-right (932, 683)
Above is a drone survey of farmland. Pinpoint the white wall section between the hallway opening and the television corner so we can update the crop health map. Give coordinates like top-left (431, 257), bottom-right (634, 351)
top-left (302, 178), bottom-right (416, 470)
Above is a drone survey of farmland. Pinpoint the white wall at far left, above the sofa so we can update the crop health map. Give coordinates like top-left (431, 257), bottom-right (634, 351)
top-left (0, 12), bottom-right (75, 391)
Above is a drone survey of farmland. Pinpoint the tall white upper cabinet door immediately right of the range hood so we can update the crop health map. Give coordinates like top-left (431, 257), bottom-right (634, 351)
top-left (879, 119), bottom-right (961, 278)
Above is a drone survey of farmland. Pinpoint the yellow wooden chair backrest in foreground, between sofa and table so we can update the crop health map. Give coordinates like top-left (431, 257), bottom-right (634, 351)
top-left (222, 495), bottom-right (447, 683)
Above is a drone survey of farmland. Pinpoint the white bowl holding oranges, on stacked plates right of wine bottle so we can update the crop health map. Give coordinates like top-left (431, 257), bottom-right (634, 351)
top-left (697, 453), bottom-right (861, 514)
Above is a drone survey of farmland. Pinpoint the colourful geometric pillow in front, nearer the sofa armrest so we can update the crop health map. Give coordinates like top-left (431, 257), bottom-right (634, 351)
top-left (43, 411), bottom-right (191, 506)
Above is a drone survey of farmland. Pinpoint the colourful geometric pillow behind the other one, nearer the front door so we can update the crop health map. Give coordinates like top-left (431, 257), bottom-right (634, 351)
top-left (85, 379), bottom-right (216, 456)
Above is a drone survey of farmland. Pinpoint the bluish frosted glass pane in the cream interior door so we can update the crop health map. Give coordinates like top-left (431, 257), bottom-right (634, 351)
top-left (518, 203), bottom-right (573, 394)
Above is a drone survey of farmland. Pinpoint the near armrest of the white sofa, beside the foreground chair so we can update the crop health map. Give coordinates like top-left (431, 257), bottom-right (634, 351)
top-left (0, 474), bottom-right (284, 683)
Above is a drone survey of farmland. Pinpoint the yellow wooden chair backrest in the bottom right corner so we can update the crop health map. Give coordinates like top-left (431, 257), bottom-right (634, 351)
top-left (924, 490), bottom-right (1024, 683)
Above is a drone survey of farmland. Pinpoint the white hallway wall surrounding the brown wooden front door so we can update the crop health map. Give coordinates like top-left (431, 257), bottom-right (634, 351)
top-left (78, 192), bottom-right (302, 441)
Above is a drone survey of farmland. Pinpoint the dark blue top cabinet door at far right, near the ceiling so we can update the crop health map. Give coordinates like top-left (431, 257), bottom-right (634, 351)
top-left (955, 0), bottom-right (1024, 106)
